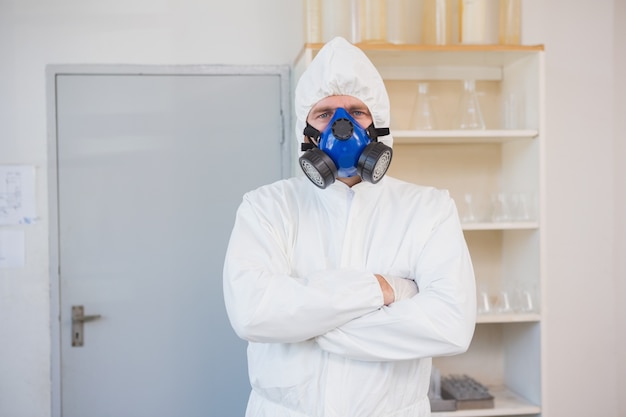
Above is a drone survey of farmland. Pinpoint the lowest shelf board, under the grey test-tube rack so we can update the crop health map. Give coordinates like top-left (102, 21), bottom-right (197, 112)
top-left (432, 387), bottom-right (541, 417)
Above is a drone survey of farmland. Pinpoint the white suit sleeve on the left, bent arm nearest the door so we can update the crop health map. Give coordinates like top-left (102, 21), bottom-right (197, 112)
top-left (223, 196), bottom-right (383, 343)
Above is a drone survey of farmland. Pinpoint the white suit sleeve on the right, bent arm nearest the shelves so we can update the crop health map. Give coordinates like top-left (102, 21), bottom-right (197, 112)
top-left (316, 198), bottom-right (476, 361)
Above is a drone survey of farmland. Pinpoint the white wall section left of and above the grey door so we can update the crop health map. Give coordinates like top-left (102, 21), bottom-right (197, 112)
top-left (0, 0), bottom-right (303, 417)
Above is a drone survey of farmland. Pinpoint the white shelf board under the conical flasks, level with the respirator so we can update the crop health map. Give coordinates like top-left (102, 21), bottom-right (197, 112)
top-left (391, 129), bottom-right (539, 144)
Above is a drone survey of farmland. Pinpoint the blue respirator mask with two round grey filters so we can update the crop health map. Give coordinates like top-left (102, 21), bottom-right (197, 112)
top-left (300, 107), bottom-right (393, 189)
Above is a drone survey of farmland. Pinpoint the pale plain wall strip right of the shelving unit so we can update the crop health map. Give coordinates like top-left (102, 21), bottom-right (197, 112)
top-left (524, 0), bottom-right (626, 417)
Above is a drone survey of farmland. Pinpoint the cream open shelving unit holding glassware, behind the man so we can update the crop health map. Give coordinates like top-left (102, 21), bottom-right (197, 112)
top-left (294, 44), bottom-right (545, 417)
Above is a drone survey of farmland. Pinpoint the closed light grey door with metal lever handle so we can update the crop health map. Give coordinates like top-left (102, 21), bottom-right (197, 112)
top-left (51, 69), bottom-right (288, 417)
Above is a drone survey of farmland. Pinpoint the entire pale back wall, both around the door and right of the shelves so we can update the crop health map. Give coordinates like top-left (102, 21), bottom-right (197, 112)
top-left (0, 0), bottom-right (626, 417)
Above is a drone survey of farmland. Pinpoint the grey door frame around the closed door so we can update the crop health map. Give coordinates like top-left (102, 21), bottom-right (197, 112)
top-left (46, 64), bottom-right (295, 417)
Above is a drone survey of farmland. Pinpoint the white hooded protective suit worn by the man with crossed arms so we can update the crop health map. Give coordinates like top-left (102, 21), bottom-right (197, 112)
top-left (224, 38), bottom-right (476, 417)
